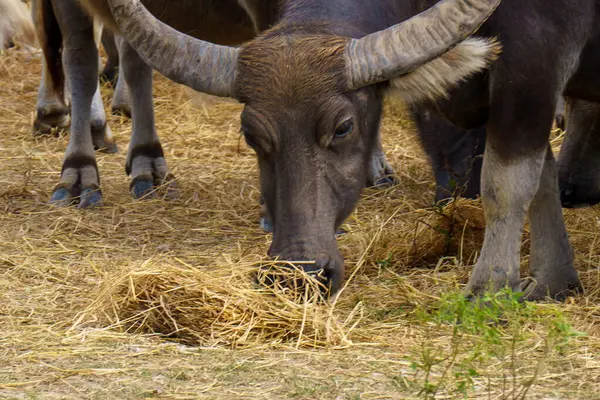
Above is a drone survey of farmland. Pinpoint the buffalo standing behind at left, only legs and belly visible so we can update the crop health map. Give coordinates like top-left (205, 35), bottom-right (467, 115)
top-left (33, 0), bottom-right (393, 207)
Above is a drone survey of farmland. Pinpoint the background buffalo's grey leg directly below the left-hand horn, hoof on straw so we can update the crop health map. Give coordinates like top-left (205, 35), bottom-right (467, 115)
top-left (120, 40), bottom-right (177, 198)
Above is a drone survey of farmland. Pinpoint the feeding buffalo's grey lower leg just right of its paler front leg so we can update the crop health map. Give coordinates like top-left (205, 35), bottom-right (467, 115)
top-left (524, 147), bottom-right (581, 300)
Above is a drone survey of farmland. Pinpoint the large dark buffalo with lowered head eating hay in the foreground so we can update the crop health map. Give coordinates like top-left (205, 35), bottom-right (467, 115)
top-left (106, 0), bottom-right (600, 299)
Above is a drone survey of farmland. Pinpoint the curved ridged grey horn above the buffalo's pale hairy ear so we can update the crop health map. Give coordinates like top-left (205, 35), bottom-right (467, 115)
top-left (346, 0), bottom-right (500, 90)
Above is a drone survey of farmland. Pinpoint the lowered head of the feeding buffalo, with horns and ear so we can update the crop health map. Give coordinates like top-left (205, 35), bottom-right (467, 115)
top-left (109, 0), bottom-right (500, 292)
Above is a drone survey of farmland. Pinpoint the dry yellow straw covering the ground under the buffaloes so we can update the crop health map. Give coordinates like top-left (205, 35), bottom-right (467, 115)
top-left (0, 46), bottom-right (600, 399)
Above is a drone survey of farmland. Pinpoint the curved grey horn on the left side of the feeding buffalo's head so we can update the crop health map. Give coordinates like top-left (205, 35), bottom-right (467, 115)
top-left (108, 0), bottom-right (239, 97)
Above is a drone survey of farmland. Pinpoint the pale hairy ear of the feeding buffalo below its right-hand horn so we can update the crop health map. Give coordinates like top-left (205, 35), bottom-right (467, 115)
top-left (388, 38), bottom-right (502, 103)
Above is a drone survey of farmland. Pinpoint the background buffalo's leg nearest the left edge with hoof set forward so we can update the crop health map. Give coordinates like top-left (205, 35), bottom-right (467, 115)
top-left (51, 1), bottom-right (102, 207)
